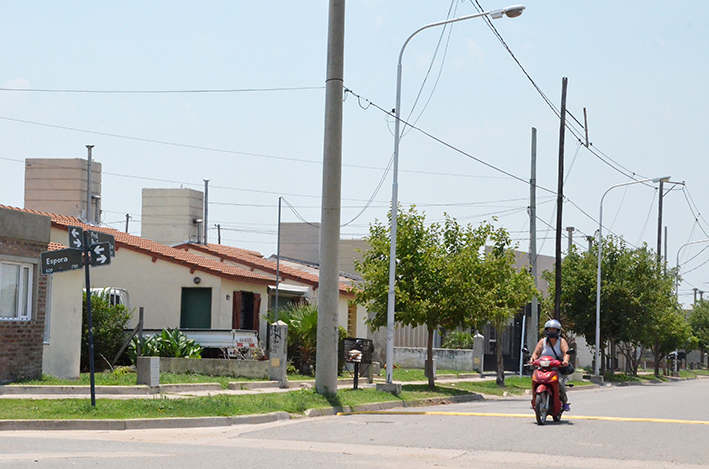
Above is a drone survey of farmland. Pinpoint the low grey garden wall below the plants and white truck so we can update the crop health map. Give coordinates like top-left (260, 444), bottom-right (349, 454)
top-left (160, 357), bottom-right (268, 379)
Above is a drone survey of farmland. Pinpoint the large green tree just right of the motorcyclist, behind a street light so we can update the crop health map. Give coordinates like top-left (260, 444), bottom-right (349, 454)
top-left (546, 236), bottom-right (682, 374)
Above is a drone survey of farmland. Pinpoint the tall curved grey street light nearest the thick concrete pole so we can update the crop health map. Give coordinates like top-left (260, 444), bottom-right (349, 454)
top-left (386, 5), bottom-right (525, 384)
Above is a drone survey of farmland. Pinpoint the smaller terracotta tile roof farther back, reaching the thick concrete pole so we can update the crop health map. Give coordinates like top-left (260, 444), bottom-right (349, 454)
top-left (175, 239), bottom-right (352, 293)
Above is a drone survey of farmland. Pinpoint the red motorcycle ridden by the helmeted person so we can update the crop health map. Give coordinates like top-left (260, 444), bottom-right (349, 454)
top-left (531, 356), bottom-right (570, 425)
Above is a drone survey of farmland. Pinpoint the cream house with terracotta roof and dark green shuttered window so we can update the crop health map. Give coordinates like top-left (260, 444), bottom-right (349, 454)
top-left (8, 207), bottom-right (367, 378)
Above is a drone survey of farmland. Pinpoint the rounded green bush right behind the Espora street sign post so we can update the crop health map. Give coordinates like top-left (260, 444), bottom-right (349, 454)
top-left (81, 291), bottom-right (131, 370)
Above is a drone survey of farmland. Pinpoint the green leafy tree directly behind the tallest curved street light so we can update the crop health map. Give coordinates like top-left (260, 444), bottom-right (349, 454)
top-left (355, 207), bottom-right (532, 388)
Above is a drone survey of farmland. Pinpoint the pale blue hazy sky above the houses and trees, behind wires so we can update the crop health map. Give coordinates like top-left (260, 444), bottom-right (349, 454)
top-left (0, 0), bottom-right (709, 302)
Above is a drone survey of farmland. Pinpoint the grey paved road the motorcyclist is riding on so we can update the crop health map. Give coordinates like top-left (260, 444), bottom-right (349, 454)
top-left (0, 380), bottom-right (709, 469)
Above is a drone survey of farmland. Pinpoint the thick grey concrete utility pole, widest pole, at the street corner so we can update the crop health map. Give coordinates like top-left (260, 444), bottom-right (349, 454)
top-left (315, 0), bottom-right (345, 394)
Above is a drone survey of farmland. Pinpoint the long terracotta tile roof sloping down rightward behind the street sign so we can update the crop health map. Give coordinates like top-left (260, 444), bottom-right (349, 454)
top-left (0, 205), bottom-right (274, 285)
